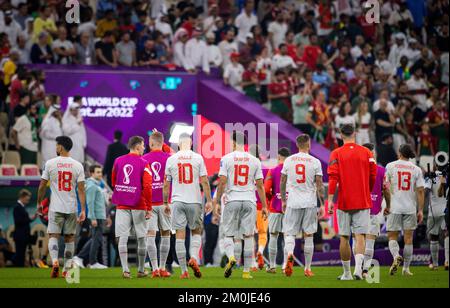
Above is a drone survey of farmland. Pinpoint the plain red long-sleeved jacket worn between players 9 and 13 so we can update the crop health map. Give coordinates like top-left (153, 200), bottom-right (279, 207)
top-left (328, 143), bottom-right (377, 211)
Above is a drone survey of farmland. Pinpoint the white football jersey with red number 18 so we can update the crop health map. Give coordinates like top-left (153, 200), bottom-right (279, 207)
top-left (42, 156), bottom-right (85, 214)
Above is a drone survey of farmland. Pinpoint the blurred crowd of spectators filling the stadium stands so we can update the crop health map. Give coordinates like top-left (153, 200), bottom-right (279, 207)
top-left (0, 0), bottom-right (449, 174)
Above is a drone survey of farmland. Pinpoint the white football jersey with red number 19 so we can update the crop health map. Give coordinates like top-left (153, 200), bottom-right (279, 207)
top-left (219, 151), bottom-right (264, 204)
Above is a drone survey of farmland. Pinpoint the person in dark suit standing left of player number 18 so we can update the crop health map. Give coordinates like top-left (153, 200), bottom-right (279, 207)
top-left (13, 189), bottom-right (37, 267)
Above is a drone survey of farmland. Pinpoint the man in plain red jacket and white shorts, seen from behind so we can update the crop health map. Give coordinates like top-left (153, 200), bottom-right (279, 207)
top-left (328, 125), bottom-right (377, 280)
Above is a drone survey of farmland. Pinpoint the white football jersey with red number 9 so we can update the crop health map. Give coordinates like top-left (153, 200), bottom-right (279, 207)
top-left (281, 153), bottom-right (323, 209)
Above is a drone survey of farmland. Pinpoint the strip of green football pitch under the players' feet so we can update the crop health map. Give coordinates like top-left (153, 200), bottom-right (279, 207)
top-left (0, 267), bottom-right (449, 288)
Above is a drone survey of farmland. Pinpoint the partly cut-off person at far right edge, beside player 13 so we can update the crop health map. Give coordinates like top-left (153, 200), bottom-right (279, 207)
top-left (425, 165), bottom-right (449, 270)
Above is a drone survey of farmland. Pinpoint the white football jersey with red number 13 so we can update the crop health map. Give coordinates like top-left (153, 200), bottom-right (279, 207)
top-left (385, 160), bottom-right (425, 215)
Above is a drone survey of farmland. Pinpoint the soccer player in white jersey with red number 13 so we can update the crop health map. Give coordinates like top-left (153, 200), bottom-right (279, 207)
top-left (385, 144), bottom-right (425, 276)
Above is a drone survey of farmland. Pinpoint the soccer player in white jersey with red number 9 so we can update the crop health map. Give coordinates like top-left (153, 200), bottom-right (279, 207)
top-left (281, 134), bottom-right (325, 277)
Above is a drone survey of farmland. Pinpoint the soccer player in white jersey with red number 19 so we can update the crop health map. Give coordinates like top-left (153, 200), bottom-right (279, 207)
top-left (214, 132), bottom-right (267, 279)
